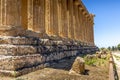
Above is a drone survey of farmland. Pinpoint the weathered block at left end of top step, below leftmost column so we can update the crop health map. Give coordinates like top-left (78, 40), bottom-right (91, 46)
top-left (0, 36), bottom-right (38, 45)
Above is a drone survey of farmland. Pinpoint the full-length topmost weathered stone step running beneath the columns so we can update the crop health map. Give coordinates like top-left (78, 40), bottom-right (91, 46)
top-left (0, 36), bottom-right (85, 46)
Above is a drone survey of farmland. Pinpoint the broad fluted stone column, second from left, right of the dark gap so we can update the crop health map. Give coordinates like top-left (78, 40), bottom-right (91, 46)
top-left (28, 0), bottom-right (45, 36)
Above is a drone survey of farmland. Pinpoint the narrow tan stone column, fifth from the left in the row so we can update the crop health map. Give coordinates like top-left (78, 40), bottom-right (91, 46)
top-left (67, 0), bottom-right (74, 39)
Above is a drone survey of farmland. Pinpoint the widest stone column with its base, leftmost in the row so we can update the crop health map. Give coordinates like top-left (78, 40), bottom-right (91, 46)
top-left (0, 0), bottom-right (23, 36)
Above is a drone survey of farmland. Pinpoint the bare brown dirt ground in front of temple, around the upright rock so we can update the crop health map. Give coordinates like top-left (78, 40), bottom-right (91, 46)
top-left (0, 57), bottom-right (108, 80)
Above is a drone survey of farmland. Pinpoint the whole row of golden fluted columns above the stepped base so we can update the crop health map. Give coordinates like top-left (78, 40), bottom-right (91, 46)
top-left (0, 0), bottom-right (94, 45)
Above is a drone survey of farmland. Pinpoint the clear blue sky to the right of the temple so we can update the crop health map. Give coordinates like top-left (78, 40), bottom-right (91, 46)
top-left (82, 0), bottom-right (120, 47)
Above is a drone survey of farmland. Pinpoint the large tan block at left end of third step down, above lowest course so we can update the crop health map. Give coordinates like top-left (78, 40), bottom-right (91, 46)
top-left (0, 54), bottom-right (43, 71)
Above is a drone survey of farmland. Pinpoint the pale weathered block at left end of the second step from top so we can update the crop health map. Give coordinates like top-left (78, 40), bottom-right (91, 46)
top-left (0, 44), bottom-right (37, 56)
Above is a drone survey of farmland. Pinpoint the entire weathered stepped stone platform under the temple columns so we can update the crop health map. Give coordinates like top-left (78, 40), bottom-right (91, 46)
top-left (0, 36), bottom-right (97, 77)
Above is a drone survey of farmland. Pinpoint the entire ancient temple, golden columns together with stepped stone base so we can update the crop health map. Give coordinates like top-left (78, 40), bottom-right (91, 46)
top-left (0, 0), bottom-right (97, 76)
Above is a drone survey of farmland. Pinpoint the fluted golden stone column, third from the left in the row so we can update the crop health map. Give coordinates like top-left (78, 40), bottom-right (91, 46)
top-left (45, 0), bottom-right (58, 36)
